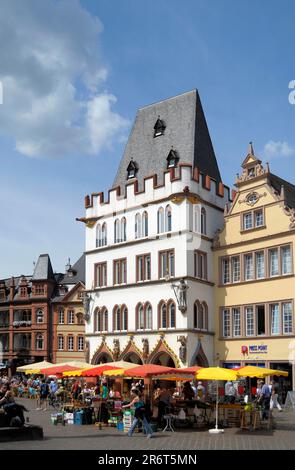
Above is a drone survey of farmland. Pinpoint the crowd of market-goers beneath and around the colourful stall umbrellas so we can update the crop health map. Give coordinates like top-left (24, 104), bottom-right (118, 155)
top-left (0, 374), bottom-right (282, 437)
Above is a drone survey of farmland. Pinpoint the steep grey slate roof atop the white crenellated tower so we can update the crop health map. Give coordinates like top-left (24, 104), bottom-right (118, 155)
top-left (113, 90), bottom-right (221, 189)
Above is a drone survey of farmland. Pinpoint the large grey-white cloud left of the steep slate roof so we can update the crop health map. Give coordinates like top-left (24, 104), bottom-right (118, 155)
top-left (0, 0), bottom-right (129, 157)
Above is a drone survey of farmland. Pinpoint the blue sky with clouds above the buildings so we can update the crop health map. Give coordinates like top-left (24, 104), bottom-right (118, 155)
top-left (0, 0), bottom-right (295, 279)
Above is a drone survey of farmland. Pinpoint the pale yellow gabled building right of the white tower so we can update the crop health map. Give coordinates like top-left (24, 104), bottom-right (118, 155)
top-left (213, 144), bottom-right (295, 393)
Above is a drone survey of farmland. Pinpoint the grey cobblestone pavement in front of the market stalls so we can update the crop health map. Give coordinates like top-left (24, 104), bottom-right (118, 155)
top-left (0, 399), bottom-right (295, 450)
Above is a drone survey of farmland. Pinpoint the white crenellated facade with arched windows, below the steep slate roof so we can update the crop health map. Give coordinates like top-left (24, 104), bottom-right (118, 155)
top-left (84, 164), bottom-right (229, 366)
